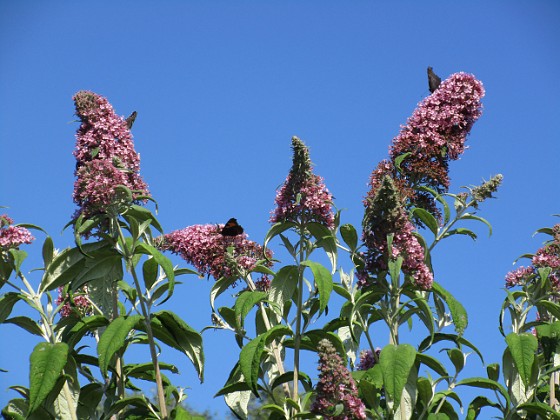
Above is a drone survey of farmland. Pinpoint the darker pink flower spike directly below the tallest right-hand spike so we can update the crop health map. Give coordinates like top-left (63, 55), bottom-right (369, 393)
top-left (358, 176), bottom-right (433, 290)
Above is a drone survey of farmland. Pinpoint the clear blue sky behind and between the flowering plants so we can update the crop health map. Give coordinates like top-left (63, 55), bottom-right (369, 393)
top-left (0, 0), bottom-right (560, 412)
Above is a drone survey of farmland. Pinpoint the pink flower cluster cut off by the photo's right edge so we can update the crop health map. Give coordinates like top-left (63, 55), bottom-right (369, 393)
top-left (506, 223), bottom-right (560, 291)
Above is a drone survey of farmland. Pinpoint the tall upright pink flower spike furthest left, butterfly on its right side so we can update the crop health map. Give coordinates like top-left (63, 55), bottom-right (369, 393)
top-left (73, 91), bottom-right (149, 217)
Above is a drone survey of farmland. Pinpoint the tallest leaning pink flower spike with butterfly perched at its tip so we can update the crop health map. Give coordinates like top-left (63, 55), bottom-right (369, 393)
top-left (370, 72), bottom-right (484, 215)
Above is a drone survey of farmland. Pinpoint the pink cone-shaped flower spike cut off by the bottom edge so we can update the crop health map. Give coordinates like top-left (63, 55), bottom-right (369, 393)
top-left (311, 339), bottom-right (366, 420)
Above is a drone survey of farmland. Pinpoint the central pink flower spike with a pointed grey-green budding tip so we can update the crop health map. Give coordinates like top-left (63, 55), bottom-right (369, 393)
top-left (270, 136), bottom-right (334, 229)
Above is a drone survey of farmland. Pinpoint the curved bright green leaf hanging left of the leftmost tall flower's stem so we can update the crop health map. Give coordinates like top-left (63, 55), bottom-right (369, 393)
top-left (97, 315), bottom-right (143, 376)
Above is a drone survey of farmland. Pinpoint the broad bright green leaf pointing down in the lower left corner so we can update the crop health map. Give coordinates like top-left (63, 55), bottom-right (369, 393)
top-left (29, 343), bottom-right (68, 413)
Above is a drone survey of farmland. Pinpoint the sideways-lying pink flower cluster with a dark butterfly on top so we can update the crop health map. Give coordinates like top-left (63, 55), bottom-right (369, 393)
top-left (158, 224), bottom-right (272, 280)
